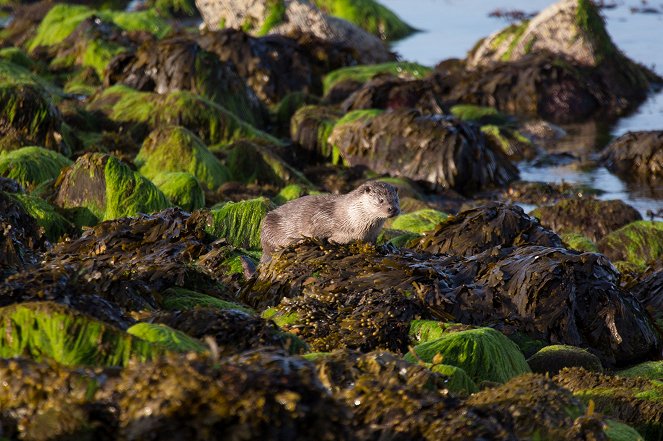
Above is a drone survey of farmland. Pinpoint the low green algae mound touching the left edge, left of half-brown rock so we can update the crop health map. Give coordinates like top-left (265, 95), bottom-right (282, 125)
top-left (0, 147), bottom-right (73, 190)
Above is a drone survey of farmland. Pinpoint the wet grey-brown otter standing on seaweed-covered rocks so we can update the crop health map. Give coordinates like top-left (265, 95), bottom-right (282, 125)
top-left (260, 181), bottom-right (401, 263)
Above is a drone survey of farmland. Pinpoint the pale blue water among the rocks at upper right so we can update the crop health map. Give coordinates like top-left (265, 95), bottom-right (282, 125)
top-left (381, 0), bottom-right (663, 216)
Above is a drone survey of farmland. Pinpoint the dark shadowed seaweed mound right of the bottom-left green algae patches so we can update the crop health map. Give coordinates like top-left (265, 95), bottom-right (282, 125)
top-left (151, 307), bottom-right (305, 356)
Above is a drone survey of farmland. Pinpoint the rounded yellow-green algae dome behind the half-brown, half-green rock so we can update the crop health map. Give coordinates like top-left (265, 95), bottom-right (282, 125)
top-left (134, 127), bottom-right (230, 190)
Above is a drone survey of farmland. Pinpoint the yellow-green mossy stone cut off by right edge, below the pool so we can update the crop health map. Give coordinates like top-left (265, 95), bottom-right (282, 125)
top-left (598, 221), bottom-right (663, 269)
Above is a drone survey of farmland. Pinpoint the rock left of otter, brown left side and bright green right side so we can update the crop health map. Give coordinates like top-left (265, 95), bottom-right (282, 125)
top-left (55, 153), bottom-right (170, 220)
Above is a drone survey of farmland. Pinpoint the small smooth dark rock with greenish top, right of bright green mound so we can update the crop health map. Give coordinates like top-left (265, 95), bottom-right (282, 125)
top-left (527, 345), bottom-right (603, 376)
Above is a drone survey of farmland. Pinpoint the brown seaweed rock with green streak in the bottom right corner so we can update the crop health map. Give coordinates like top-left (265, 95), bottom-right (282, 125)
top-left (554, 368), bottom-right (663, 441)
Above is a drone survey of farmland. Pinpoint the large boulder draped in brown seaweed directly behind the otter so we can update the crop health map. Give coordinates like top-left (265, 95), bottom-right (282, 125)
top-left (329, 110), bottom-right (518, 193)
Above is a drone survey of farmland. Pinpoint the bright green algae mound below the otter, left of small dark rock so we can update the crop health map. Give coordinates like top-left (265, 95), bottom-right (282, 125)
top-left (405, 328), bottom-right (530, 383)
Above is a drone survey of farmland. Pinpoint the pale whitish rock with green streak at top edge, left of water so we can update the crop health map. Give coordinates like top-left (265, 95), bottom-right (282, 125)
top-left (196, 0), bottom-right (393, 64)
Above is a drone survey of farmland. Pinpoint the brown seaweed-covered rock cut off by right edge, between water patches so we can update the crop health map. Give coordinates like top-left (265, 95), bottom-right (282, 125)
top-left (602, 131), bottom-right (663, 182)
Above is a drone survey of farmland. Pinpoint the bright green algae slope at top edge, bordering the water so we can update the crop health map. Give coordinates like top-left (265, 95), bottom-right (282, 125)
top-left (313, 0), bottom-right (416, 40)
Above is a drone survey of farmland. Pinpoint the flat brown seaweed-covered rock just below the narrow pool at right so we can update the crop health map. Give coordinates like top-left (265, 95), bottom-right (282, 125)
top-left (530, 198), bottom-right (642, 242)
